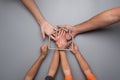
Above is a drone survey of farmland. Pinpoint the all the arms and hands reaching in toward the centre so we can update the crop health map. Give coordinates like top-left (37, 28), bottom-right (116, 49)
top-left (21, 0), bottom-right (120, 80)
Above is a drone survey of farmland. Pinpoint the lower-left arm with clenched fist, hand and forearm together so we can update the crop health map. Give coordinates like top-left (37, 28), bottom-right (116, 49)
top-left (24, 45), bottom-right (48, 80)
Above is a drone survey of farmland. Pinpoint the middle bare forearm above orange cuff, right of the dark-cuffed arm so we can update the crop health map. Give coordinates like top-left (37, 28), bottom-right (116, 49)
top-left (60, 51), bottom-right (71, 76)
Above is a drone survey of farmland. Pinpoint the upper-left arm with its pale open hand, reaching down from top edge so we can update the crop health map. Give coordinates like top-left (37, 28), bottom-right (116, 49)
top-left (21, 0), bottom-right (54, 39)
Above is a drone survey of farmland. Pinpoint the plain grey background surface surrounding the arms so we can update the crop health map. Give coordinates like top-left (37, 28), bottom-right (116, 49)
top-left (0, 0), bottom-right (120, 80)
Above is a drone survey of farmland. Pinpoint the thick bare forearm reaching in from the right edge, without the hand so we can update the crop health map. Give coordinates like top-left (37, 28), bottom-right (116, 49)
top-left (74, 8), bottom-right (120, 33)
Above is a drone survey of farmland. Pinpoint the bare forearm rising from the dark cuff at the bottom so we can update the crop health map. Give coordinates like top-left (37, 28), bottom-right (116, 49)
top-left (48, 51), bottom-right (59, 77)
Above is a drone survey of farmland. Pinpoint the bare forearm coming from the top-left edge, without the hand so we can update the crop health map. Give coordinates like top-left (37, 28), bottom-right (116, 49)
top-left (21, 0), bottom-right (46, 25)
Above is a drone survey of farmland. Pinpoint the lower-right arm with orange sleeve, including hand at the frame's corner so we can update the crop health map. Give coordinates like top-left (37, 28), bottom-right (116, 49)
top-left (68, 43), bottom-right (96, 80)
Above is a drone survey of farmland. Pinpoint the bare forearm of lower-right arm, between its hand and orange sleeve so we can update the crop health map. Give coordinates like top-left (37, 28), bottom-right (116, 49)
top-left (75, 52), bottom-right (92, 75)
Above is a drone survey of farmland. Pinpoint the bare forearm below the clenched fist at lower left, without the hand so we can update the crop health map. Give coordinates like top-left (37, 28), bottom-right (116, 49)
top-left (24, 56), bottom-right (44, 80)
